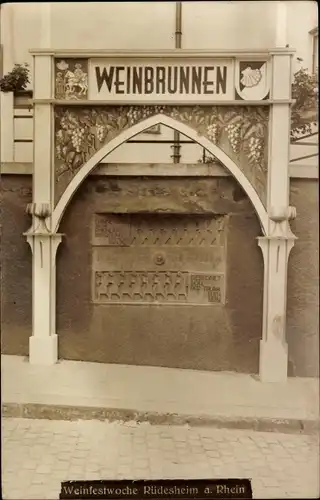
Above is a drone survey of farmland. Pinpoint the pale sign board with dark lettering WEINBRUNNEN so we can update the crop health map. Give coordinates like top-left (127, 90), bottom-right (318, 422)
top-left (88, 59), bottom-right (234, 104)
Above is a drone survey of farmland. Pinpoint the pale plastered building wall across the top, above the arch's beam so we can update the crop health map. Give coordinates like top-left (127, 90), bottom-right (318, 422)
top-left (1, 0), bottom-right (317, 76)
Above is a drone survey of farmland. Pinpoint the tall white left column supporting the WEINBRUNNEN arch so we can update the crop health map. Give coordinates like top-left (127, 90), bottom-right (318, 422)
top-left (25, 54), bottom-right (62, 365)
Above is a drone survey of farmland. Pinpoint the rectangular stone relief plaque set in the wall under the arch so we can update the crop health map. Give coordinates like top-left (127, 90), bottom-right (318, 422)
top-left (92, 214), bottom-right (225, 305)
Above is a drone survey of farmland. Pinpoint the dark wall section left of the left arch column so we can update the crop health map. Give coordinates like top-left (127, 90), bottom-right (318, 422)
top-left (0, 175), bottom-right (32, 355)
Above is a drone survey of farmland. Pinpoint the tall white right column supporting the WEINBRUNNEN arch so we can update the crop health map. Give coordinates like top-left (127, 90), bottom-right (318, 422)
top-left (258, 48), bottom-right (296, 382)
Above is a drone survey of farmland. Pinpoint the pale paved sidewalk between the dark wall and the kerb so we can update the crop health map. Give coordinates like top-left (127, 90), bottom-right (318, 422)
top-left (2, 355), bottom-right (319, 425)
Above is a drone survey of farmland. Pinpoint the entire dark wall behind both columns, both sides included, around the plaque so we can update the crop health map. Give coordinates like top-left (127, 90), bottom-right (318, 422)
top-left (1, 175), bottom-right (319, 377)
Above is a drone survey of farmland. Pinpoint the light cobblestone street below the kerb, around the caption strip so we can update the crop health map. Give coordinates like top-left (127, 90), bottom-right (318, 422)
top-left (2, 418), bottom-right (319, 500)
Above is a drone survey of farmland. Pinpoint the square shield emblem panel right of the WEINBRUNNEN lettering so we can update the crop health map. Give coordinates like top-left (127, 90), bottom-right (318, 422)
top-left (235, 61), bottom-right (270, 101)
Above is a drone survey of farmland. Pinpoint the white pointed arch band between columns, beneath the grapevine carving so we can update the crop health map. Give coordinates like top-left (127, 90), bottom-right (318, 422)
top-left (51, 113), bottom-right (268, 234)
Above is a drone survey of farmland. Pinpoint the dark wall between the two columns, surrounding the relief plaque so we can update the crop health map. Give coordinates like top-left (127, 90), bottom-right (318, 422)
top-left (57, 178), bottom-right (263, 373)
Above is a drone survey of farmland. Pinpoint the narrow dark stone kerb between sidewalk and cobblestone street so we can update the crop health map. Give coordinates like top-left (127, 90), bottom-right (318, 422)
top-left (2, 403), bottom-right (320, 434)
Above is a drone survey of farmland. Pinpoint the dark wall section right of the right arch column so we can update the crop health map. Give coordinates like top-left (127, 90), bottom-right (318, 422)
top-left (287, 179), bottom-right (319, 377)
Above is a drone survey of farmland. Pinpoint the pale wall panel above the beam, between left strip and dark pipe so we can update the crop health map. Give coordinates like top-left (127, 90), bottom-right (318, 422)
top-left (51, 2), bottom-right (175, 49)
